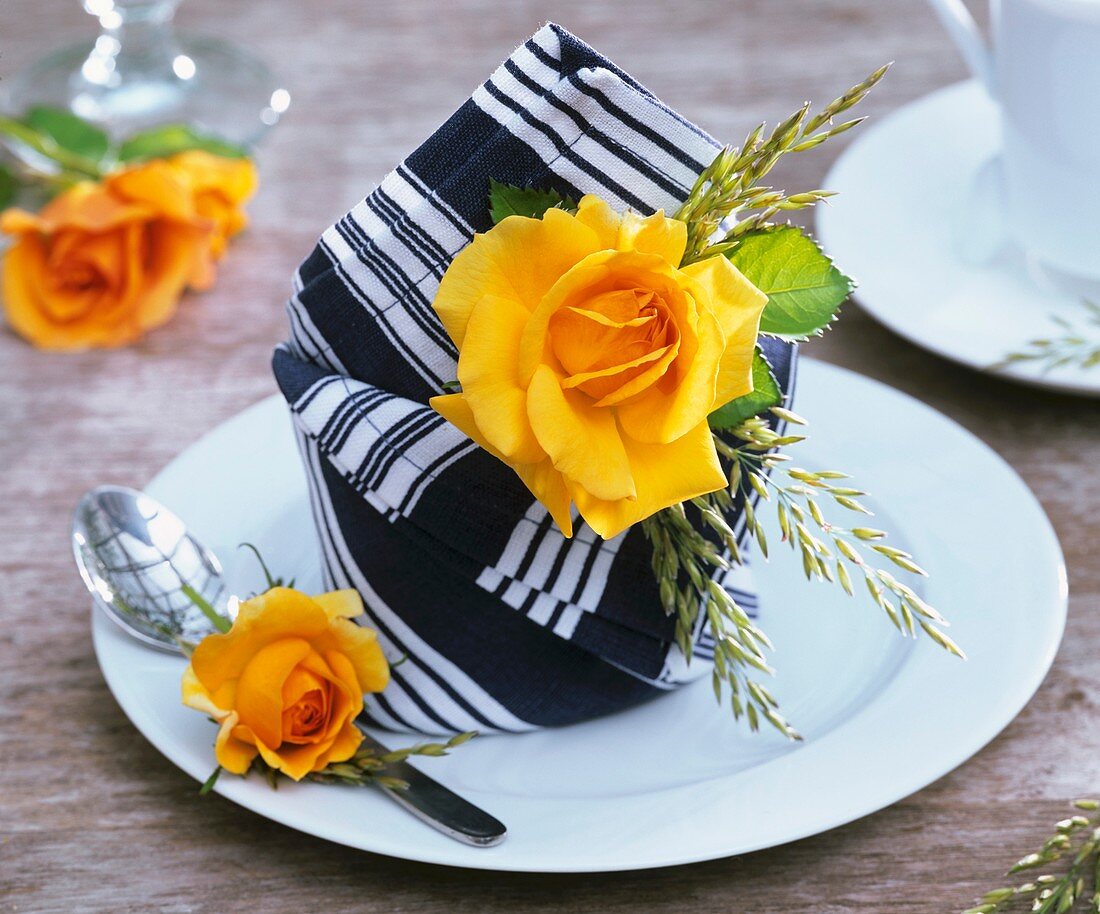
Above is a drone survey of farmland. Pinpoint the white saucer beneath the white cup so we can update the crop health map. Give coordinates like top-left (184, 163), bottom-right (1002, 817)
top-left (817, 81), bottom-right (1100, 396)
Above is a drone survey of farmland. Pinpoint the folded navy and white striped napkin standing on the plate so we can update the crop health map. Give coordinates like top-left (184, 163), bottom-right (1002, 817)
top-left (274, 24), bottom-right (795, 733)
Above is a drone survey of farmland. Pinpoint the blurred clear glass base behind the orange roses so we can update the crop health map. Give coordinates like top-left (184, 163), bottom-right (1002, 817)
top-left (0, 32), bottom-right (290, 146)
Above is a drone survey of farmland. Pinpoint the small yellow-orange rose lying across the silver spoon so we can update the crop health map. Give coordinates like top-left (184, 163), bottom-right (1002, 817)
top-left (183, 587), bottom-right (389, 781)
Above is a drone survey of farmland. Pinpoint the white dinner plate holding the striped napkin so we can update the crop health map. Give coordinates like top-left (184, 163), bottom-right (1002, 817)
top-left (92, 360), bottom-right (1066, 872)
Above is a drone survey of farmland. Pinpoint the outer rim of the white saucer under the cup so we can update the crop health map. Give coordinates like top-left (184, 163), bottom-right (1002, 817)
top-left (814, 78), bottom-right (1100, 399)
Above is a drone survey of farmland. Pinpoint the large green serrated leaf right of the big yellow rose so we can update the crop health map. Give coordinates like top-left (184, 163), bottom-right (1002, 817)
top-left (729, 225), bottom-right (855, 340)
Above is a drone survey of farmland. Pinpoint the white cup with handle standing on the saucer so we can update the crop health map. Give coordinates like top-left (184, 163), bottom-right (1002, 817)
top-left (928, 0), bottom-right (1100, 278)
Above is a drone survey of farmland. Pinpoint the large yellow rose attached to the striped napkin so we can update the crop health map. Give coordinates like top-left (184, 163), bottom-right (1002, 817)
top-left (431, 196), bottom-right (768, 538)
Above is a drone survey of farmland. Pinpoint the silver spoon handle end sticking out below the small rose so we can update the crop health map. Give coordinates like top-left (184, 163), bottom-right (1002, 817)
top-left (363, 733), bottom-right (507, 847)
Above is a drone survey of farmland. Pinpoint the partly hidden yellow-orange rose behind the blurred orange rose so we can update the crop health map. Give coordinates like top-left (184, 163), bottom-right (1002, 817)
top-left (168, 150), bottom-right (260, 258)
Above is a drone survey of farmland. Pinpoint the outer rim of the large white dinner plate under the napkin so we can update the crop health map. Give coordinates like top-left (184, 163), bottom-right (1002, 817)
top-left (92, 359), bottom-right (1068, 873)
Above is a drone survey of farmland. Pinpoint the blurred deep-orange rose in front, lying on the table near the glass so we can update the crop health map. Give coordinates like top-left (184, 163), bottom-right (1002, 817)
top-left (0, 162), bottom-right (212, 350)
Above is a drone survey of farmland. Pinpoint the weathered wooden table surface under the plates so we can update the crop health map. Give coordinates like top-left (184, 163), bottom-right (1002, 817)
top-left (0, 0), bottom-right (1100, 914)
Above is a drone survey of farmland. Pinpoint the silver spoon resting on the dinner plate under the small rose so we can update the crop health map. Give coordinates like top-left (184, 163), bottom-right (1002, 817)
top-left (73, 486), bottom-right (506, 847)
